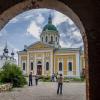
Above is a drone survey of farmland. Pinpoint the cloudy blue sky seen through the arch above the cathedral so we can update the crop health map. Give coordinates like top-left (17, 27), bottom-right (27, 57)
top-left (0, 9), bottom-right (83, 59)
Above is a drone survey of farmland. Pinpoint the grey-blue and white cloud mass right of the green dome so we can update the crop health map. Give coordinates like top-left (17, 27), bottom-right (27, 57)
top-left (57, 19), bottom-right (83, 48)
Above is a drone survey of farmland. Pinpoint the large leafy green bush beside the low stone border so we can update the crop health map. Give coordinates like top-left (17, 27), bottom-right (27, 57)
top-left (0, 63), bottom-right (27, 87)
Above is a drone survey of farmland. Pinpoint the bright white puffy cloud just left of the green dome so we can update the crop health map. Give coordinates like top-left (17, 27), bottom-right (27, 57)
top-left (26, 21), bottom-right (42, 40)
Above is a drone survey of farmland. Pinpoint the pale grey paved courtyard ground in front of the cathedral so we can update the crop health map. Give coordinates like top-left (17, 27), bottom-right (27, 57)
top-left (0, 82), bottom-right (86, 100)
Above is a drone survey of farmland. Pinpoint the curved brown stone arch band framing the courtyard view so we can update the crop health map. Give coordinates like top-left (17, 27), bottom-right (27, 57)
top-left (0, 0), bottom-right (90, 100)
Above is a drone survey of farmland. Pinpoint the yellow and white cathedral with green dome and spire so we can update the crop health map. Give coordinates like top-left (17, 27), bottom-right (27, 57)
top-left (18, 16), bottom-right (85, 78)
